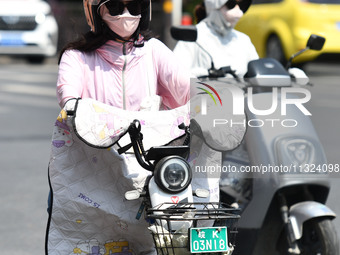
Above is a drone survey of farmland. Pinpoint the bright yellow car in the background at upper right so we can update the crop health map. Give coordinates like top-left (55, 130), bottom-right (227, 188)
top-left (236, 0), bottom-right (340, 63)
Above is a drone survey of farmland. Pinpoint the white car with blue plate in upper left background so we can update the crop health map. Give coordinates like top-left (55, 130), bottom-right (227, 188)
top-left (0, 0), bottom-right (58, 63)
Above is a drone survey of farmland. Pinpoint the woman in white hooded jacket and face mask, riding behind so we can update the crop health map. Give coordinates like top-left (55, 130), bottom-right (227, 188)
top-left (174, 0), bottom-right (258, 77)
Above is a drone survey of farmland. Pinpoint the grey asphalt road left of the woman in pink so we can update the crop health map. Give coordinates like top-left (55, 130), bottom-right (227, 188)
top-left (0, 57), bottom-right (59, 255)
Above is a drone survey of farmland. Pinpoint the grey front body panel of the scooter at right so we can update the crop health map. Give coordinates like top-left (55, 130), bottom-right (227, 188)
top-left (239, 93), bottom-right (329, 229)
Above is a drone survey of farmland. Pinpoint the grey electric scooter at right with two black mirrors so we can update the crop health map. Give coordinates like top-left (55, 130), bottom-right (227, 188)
top-left (171, 26), bottom-right (339, 255)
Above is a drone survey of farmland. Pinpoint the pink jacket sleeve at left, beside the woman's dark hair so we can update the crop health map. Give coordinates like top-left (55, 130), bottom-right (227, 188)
top-left (57, 50), bottom-right (84, 107)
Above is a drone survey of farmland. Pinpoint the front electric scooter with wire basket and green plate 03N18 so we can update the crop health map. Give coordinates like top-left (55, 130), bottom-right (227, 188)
top-left (118, 120), bottom-right (240, 255)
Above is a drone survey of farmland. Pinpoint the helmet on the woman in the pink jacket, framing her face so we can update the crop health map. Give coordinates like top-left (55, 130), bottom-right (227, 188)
top-left (83, 0), bottom-right (151, 33)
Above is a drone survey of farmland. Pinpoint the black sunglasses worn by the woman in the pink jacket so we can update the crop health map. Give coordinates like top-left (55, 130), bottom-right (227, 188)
top-left (105, 0), bottom-right (142, 16)
